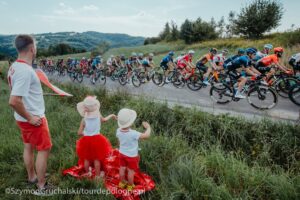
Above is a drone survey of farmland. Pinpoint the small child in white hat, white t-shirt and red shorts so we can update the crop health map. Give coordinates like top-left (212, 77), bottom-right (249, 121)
top-left (117, 108), bottom-right (151, 191)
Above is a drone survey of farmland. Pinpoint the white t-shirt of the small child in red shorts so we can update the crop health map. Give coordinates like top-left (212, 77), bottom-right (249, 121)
top-left (117, 128), bottom-right (141, 157)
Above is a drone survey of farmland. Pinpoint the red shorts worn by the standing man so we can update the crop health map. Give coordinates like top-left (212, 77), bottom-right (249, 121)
top-left (17, 117), bottom-right (52, 151)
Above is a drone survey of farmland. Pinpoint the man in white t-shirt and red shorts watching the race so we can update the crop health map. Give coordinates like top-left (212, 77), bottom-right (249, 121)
top-left (8, 35), bottom-right (52, 195)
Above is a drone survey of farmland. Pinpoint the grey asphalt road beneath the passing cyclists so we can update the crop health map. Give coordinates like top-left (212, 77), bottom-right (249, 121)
top-left (49, 76), bottom-right (300, 122)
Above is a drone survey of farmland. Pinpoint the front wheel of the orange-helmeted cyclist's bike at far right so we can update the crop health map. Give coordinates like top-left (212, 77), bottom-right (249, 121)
top-left (275, 77), bottom-right (298, 98)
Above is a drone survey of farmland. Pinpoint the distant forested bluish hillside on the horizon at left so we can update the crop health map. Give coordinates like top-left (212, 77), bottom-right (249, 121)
top-left (0, 31), bottom-right (144, 56)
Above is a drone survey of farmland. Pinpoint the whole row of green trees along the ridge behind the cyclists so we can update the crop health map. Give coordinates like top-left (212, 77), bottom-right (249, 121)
top-left (144, 0), bottom-right (283, 45)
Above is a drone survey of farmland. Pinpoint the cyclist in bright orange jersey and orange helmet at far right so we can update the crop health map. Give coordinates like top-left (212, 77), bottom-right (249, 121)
top-left (255, 47), bottom-right (289, 80)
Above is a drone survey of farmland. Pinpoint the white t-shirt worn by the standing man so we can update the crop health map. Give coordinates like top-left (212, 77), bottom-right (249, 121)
top-left (8, 62), bottom-right (45, 122)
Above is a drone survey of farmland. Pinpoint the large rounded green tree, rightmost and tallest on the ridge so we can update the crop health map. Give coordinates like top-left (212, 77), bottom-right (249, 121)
top-left (234, 0), bottom-right (283, 38)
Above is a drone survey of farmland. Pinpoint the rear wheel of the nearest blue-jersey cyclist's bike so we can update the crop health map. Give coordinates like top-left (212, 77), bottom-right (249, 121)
top-left (209, 83), bottom-right (234, 104)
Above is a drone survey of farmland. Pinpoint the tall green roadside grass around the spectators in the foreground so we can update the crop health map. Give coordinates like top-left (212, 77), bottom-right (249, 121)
top-left (0, 62), bottom-right (300, 200)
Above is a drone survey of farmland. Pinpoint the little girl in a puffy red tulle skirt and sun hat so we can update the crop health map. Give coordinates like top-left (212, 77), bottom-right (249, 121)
top-left (76, 96), bottom-right (117, 179)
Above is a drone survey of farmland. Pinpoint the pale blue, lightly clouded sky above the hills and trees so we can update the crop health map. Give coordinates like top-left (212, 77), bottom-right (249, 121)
top-left (0, 0), bottom-right (300, 37)
